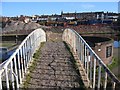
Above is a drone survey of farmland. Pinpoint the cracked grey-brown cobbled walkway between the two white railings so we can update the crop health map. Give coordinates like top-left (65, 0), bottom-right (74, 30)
top-left (28, 41), bottom-right (84, 90)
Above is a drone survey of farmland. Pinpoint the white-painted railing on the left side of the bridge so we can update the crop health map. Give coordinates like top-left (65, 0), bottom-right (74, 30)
top-left (0, 28), bottom-right (46, 90)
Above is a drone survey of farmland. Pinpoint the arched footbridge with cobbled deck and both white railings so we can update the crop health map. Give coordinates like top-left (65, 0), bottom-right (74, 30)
top-left (0, 28), bottom-right (120, 90)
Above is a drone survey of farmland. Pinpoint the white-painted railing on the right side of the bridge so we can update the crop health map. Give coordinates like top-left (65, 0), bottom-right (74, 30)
top-left (62, 29), bottom-right (120, 89)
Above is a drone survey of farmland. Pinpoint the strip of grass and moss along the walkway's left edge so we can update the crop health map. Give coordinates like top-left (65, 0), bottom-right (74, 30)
top-left (23, 42), bottom-right (45, 89)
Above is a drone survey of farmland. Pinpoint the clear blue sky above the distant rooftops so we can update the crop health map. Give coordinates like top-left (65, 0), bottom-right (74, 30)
top-left (0, 2), bottom-right (118, 17)
